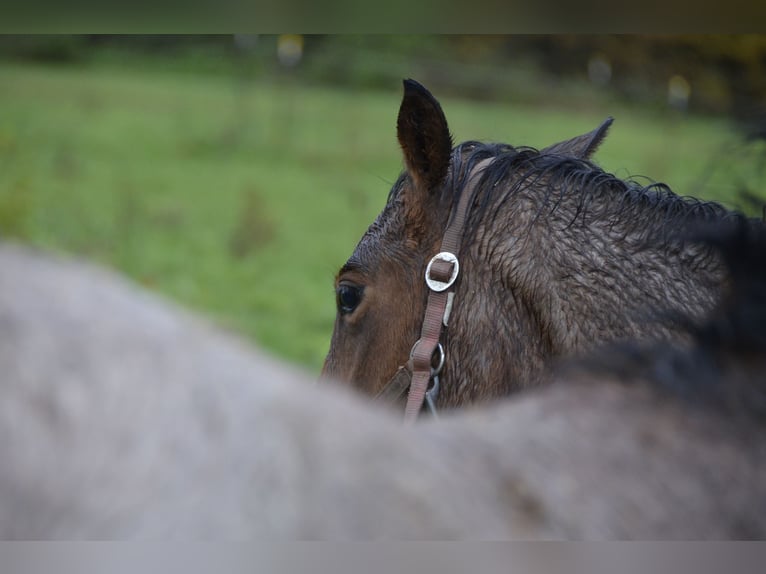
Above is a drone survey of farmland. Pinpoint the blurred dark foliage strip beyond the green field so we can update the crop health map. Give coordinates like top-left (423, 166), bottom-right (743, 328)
top-left (0, 35), bottom-right (766, 120)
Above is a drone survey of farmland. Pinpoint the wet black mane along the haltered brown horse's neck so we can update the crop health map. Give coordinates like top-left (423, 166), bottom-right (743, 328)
top-left (445, 141), bottom-right (740, 245)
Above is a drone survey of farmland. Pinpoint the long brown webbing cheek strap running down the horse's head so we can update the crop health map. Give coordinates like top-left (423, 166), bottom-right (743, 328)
top-left (404, 158), bottom-right (494, 423)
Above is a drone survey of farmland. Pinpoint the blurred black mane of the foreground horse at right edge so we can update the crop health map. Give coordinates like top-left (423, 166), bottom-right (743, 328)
top-left (559, 219), bottom-right (766, 424)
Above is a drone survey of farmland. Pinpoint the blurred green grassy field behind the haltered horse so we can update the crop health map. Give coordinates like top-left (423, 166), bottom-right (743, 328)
top-left (0, 58), bottom-right (762, 371)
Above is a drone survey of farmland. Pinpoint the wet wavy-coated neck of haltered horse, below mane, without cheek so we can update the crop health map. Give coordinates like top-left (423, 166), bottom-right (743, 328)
top-left (498, 181), bottom-right (722, 354)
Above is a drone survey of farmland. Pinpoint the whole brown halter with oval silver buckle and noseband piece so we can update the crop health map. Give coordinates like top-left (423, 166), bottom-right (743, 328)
top-left (376, 158), bottom-right (494, 423)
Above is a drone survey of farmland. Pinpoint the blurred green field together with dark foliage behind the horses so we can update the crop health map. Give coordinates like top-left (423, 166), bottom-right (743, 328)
top-left (0, 34), bottom-right (766, 372)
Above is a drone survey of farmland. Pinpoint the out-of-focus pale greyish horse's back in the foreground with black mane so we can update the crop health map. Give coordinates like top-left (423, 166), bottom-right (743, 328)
top-left (0, 220), bottom-right (766, 540)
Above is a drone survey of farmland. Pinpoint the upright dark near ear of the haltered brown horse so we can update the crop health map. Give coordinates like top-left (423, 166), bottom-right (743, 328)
top-left (396, 80), bottom-right (452, 191)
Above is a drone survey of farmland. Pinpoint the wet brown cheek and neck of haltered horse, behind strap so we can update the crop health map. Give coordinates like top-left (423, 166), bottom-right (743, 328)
top-left (448, 174), bottom-right (723, 399)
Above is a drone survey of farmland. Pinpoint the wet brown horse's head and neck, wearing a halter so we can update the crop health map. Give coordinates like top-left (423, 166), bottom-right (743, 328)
top-left (323, 80), bottom-right (739, 407)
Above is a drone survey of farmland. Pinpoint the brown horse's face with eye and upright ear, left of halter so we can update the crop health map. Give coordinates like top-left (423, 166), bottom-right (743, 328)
top-left (322, 80), bottom-right (452, 394)
